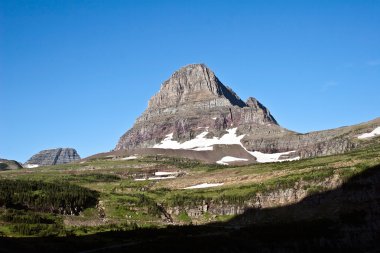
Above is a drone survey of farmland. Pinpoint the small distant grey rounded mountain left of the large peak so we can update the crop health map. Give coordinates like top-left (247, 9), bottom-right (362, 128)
top-left (24, 148), bottom-right (80, 168)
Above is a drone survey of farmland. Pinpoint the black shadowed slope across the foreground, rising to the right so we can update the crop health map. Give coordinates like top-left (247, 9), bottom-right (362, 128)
top-left (0, 165), bottom-right (380, 252)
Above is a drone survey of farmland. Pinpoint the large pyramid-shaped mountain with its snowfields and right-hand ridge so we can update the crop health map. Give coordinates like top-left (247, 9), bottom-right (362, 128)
top-left (115, 64), bottom-right (380, 162)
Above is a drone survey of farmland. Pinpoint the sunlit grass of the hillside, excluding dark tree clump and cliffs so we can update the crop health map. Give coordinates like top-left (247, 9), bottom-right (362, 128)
top-left (0, 138), bottom-right (380, 236)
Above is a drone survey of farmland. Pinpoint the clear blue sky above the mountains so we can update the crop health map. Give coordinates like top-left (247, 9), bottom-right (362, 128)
top-left (0, 0), bottom-right (380, 162)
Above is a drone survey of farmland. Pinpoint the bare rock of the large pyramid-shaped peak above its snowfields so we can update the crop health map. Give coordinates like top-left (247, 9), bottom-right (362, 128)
top-left (115, 64), bottom-right (280, 150)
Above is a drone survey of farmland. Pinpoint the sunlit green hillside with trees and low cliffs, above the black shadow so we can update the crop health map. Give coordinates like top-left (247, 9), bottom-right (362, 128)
top-left (0, 138), bottom-right (380, 237)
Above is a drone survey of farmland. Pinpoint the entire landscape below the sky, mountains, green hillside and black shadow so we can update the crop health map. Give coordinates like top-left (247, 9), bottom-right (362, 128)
top-left (0, 64), bottom-right (380, 252)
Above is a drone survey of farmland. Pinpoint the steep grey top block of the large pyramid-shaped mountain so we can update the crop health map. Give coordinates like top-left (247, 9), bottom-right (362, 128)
top-left (148, 64), bottom-right (247, 109)
